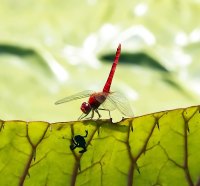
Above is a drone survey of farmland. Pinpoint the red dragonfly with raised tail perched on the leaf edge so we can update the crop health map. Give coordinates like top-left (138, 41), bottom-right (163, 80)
top-left (55, 44), bottom-right (133, 120)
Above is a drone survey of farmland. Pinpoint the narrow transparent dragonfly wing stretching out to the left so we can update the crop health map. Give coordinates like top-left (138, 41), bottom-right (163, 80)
top-left (55, 90), bottom-right (94, 105)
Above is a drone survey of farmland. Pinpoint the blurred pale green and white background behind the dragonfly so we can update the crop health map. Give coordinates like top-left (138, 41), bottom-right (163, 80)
top-left (0, 0), bottom-right (200, 122)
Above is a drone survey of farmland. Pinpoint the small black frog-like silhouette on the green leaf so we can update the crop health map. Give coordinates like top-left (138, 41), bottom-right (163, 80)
top-left (70, 130), bottom-right (88, 153)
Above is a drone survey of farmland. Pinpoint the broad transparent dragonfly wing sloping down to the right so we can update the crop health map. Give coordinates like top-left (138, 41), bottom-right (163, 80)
top-left (107, 92), bottom-right (134, 117)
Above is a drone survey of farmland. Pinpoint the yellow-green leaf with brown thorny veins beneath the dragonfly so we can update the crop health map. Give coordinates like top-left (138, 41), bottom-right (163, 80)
top-left (0, 106), bottom-right (200, 186)
